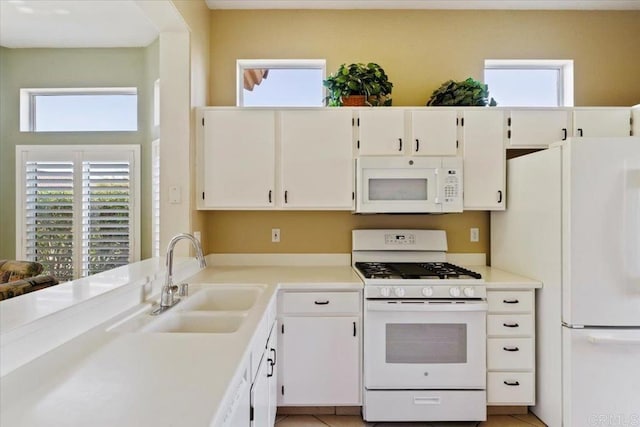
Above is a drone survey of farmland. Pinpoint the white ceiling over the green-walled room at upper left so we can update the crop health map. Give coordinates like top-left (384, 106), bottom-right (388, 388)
top-left (0, 0), bottom-right (158, 48)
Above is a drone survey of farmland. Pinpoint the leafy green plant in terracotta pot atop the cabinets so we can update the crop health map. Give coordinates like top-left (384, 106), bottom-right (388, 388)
top-left (322, 62), bottom-right (393, 106)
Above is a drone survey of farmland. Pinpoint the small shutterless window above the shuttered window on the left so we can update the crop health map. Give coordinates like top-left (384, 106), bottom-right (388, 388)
top-left (20, 88), bottom-right (138, 132)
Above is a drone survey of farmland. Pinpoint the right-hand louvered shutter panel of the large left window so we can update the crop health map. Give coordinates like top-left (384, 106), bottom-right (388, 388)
top-left (82, 155), bottom-right (132, 277)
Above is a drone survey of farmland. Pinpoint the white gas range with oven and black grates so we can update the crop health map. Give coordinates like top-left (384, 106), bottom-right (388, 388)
top-left (352, 230), bottom-right (487, 421)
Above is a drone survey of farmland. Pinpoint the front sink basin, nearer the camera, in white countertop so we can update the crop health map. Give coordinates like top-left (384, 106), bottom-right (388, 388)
top-left (141, 312), bottom-right (247, 334)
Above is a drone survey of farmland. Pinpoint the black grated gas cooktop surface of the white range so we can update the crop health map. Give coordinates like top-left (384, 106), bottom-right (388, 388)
top-left (355, 262), bottom-right (482, 281)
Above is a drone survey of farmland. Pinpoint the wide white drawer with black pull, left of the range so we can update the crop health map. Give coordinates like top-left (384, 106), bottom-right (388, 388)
top-left (282, 292), bottom-right (362, 314)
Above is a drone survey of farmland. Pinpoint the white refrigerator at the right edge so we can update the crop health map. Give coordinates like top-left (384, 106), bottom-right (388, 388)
top-left (491, 137), bottom-right (640, 427)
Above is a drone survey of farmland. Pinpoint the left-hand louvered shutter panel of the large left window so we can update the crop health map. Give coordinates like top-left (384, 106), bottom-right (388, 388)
top-left (24, 161), bottom-right (74, 282)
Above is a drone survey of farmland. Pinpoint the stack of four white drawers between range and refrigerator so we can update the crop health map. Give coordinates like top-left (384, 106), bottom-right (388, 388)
top-left (487, 286), bottom-right (536, 406)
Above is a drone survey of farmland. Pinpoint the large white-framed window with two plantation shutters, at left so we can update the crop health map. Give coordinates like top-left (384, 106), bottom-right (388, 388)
top-left (16, 145), bottom-right (140, 281)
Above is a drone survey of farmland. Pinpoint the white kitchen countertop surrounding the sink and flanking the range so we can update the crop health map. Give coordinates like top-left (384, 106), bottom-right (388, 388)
top-left (0, 265), bottom-right (541, 427)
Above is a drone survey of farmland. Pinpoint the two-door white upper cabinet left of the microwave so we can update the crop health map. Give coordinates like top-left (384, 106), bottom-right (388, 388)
top-left (197, 108), bottom-right (355, 210)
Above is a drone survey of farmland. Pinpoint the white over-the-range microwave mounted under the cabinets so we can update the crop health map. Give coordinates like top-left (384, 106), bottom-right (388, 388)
top-left (355, 156), bottom-right (463, 213)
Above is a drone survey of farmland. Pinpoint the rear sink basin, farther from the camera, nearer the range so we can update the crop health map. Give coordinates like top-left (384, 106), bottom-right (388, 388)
top-left (176, 285), bottom-right (265, 311)
